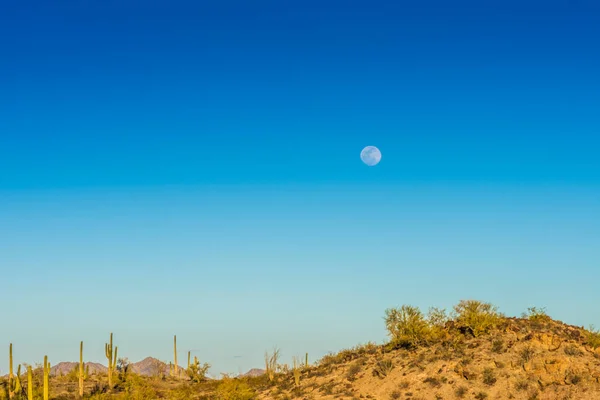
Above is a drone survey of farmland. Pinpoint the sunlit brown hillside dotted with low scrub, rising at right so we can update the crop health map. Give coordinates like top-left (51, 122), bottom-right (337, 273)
top-left (259, 312), bottom-right (600, 400)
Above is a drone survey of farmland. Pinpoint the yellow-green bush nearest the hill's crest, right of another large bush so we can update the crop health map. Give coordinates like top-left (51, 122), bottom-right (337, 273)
top-left (454, 300), bottom-right (502, 337)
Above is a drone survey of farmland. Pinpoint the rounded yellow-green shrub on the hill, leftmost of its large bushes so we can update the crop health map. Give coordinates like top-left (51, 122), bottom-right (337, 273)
top-left (385, 305), bottom-right (430, 345)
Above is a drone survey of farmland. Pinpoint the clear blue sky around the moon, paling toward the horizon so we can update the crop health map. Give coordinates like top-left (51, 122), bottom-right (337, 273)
top-left (0, 0), bottom-right (600, 376)
